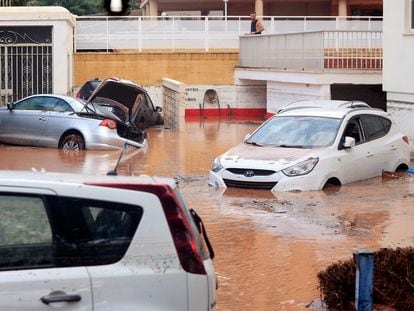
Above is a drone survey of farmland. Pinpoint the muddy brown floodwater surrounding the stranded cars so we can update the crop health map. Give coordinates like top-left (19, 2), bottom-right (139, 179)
top-left (0, 120), bottom-right (414, 310)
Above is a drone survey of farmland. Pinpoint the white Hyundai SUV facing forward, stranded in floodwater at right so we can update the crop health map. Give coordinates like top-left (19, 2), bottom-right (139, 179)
top-left (209, 100), bottom-right (410, 192)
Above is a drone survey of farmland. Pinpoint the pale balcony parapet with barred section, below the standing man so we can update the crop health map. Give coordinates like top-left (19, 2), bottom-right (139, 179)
top-left (239, 30), bottom-right (382, 71)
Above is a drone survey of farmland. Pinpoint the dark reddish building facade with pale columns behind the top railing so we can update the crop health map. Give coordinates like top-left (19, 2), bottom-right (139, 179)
top-left (141, 0), bottom-right (383, 16)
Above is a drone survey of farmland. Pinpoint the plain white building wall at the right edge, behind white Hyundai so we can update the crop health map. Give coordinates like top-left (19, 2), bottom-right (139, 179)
top-left (383, 0), bottom-right (414, 149)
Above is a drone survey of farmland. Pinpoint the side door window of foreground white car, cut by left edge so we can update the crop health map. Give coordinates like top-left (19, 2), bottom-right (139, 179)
top-left (0, 194), bottom-right (53, 270)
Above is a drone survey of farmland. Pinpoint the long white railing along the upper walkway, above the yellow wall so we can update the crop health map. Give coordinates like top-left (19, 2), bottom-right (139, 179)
top-left (75, 16), bottom-right (382, 52)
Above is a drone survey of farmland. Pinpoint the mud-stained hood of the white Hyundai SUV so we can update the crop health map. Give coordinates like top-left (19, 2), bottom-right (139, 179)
top-left (221, 143), bottom-right (315, 170)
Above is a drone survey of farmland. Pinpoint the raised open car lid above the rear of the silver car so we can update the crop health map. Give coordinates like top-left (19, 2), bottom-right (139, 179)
top-left (88, 79), bottom-right (146, 122)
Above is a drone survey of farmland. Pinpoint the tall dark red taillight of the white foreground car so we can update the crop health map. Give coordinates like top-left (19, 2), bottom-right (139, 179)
top-left (86, 183), bottom-right (207, 275)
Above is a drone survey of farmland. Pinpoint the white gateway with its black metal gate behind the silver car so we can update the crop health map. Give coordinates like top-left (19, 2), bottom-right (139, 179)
top-left (0, 7), bottom-right (75, 104)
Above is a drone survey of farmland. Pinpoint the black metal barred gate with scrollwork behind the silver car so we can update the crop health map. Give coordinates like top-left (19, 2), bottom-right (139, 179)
top-left (0, 26), bottom-right (53, 106)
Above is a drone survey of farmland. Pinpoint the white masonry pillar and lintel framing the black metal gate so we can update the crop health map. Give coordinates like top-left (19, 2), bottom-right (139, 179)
top-left (0, 7), bottom-right (75, 94)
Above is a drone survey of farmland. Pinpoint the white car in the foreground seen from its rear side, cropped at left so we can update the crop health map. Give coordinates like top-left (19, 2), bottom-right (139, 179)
top-left (0, 171), bottom-right (217, 311)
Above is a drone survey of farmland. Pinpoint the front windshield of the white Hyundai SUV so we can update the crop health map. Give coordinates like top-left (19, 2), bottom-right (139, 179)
top-left (246, 116), bottom-right (341, 148)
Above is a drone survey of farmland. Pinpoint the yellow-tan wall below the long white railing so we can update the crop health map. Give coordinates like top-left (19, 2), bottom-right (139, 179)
top-left (74, 51), bottom-right (239, 86)
